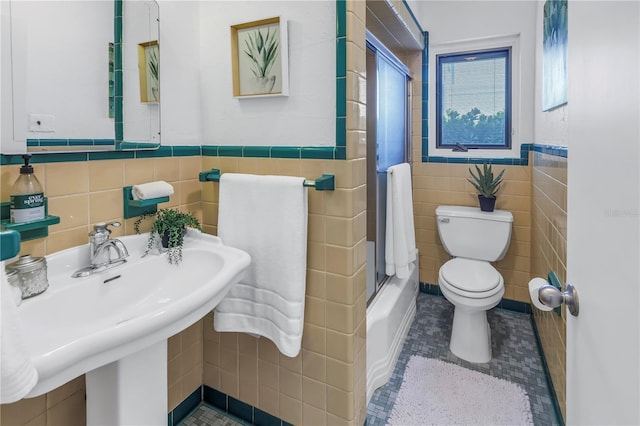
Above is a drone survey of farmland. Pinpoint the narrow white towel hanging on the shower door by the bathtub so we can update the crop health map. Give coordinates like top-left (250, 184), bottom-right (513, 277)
top-left (384, 163), bottom-right (416, 278)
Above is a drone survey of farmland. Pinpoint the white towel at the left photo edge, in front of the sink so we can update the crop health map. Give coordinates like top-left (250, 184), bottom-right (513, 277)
top-left (0, 262), bottom-right (38, 404)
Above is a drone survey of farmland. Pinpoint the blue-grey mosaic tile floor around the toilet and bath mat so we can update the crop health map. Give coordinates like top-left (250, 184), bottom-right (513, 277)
top-left (181, 293), bottom-right (559, 426)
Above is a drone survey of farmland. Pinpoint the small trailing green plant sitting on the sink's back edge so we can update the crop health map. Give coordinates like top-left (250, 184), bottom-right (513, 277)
top-left (134, 209), bottom-right (202, 264)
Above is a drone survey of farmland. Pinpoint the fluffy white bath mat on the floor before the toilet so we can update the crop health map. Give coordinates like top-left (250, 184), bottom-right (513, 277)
top-left (388, 355), bottom-right (533, 426)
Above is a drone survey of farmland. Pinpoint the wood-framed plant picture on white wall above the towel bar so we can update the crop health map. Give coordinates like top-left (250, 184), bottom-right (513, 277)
top-left (231, 17), bottom-right (289, 98)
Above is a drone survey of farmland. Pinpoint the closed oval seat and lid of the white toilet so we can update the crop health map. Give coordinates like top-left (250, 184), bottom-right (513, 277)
top-left (439, 258), bottom-right (504, 299)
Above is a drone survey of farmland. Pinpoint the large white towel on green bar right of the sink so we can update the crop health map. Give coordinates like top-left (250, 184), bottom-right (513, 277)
top-left (214, 173), bottom-right (307, 357)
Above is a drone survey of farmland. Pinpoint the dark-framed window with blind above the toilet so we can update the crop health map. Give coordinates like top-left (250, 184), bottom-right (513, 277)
top-left (436, 47), bottom-right (511, 151)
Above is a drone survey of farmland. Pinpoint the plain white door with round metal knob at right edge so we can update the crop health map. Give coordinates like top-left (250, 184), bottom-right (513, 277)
top-left (567, 1), bottom-right (640, 425)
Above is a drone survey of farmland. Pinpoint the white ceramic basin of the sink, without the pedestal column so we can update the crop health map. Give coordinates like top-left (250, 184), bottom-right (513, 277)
top-left (18, 230), bottom-right (250, 400)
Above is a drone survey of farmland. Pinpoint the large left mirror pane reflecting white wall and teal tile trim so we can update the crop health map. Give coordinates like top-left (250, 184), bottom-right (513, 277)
top-left (10, 0), bottom-right (115, 151)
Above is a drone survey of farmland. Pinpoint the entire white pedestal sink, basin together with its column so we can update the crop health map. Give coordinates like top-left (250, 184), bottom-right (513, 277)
top-left (18, 230), bottom-right (251, 425)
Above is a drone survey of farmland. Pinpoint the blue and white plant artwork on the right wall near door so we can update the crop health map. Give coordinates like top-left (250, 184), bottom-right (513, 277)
top-left (542, 0), bottom-right (568, 111)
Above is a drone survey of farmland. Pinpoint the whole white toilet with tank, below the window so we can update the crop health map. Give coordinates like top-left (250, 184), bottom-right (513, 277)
top-left (436, 206), bottom-right (513, 363)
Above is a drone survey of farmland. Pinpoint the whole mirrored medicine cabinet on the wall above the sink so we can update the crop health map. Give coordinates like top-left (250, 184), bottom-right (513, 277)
top-left (2, 0), bottom-right (160, 154)
